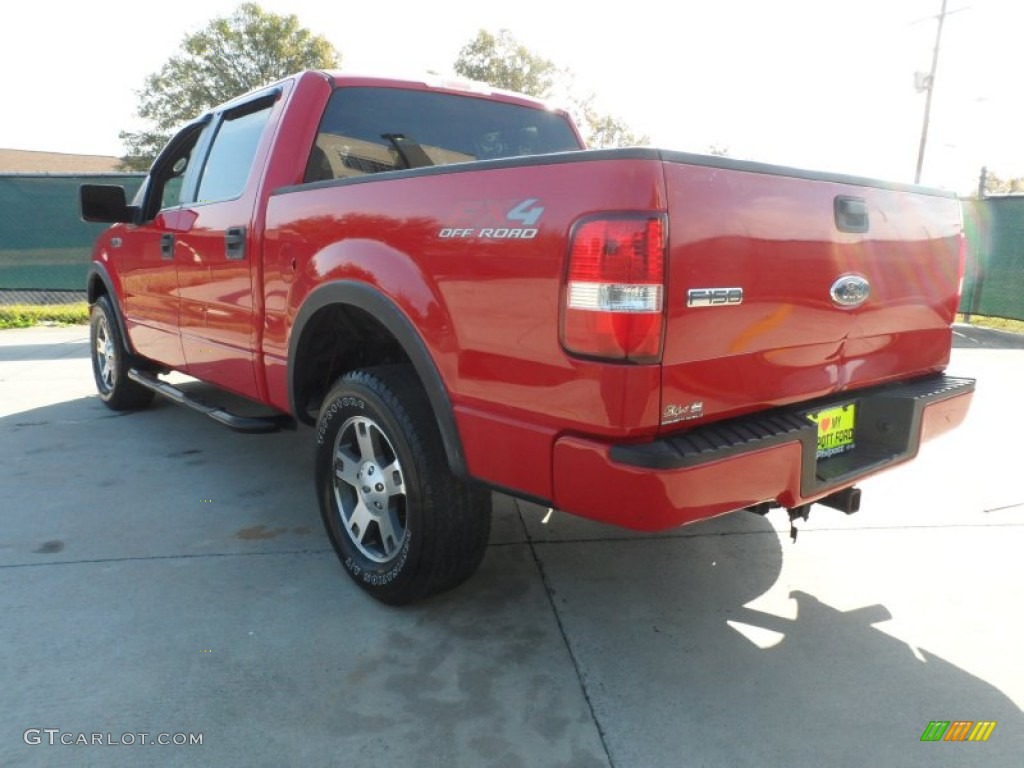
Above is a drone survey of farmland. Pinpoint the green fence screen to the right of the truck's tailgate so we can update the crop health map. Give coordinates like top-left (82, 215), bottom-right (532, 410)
top-left (961, 196), bottom-right (1024, 321)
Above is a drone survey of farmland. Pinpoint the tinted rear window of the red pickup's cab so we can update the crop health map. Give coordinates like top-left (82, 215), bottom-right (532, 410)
top-left (305, 87), bottom-right (580, 182)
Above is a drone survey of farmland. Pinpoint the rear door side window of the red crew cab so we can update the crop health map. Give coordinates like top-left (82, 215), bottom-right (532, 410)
top-left (196, 99), bottom-right (273, 203)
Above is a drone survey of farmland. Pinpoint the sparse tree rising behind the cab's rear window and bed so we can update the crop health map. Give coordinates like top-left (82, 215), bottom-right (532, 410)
top-left (454, 30), bottom-right (650, 147)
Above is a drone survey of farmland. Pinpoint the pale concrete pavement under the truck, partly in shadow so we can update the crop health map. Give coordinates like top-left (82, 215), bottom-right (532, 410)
top-left (0, 328), bottom-right (1024, 768)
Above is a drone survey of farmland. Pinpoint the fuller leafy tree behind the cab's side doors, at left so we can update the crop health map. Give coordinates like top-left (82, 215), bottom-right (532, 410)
top-left (119, 3), bottom-right (341, 170)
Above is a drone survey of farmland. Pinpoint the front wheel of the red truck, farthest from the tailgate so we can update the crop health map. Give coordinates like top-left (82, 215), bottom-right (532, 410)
top-left (89, 296), bottom-right (155, 411)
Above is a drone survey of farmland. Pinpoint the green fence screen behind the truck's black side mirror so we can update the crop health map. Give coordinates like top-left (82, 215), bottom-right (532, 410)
top-left (0, 173), bottom-right (144, 291)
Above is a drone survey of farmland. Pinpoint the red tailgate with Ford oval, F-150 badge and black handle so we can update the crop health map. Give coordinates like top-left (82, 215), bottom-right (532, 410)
top-left (662, 153), bottom-right (962, 428)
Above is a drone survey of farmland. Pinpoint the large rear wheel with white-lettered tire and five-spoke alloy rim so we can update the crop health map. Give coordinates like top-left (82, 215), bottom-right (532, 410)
top-left (316, 366), bottom-right (490, 605)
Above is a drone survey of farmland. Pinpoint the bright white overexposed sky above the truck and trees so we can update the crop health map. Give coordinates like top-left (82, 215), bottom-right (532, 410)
top-left (0, 0), bottom-right (1024, 194)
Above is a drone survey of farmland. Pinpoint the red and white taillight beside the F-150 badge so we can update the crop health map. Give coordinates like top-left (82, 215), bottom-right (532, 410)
top-left (562, 214), bottom-right (666, 362)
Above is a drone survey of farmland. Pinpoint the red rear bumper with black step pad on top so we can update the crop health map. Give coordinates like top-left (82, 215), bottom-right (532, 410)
top-left (554, 375), bottom-right (975, 530)
